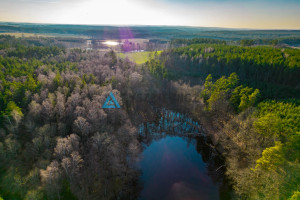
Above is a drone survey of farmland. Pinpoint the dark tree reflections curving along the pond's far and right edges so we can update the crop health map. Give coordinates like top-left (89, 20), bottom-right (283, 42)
top-left (138, 108), bottom-right (229, 199)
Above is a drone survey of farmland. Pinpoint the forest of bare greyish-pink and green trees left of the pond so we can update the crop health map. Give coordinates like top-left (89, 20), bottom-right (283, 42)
top-left (0, 37), bottom-right (161, 199)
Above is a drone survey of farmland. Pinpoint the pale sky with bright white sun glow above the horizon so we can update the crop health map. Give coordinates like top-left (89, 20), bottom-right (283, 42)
top-left (0, 0), bottom-right (300, 29)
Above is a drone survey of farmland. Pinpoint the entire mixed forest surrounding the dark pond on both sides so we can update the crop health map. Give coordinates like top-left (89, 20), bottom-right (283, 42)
top-left (0, 36), bottom-right (300, 200)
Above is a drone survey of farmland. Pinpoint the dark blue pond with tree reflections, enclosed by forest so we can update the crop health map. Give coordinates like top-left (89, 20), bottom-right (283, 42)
top-left (138, 110), bottom-right (229, 200)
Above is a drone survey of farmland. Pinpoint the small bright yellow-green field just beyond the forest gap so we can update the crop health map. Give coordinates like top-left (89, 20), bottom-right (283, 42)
top-left (118, 51), bottom-right (161, 64)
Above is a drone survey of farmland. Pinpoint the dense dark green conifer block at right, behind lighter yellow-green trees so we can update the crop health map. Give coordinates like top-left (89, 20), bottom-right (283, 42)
top-left (160, 44), bottom-right (300, 99)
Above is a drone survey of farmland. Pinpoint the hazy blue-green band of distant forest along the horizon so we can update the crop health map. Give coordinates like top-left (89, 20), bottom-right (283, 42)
top-left (0, 22), bottom-right (300, 40)
